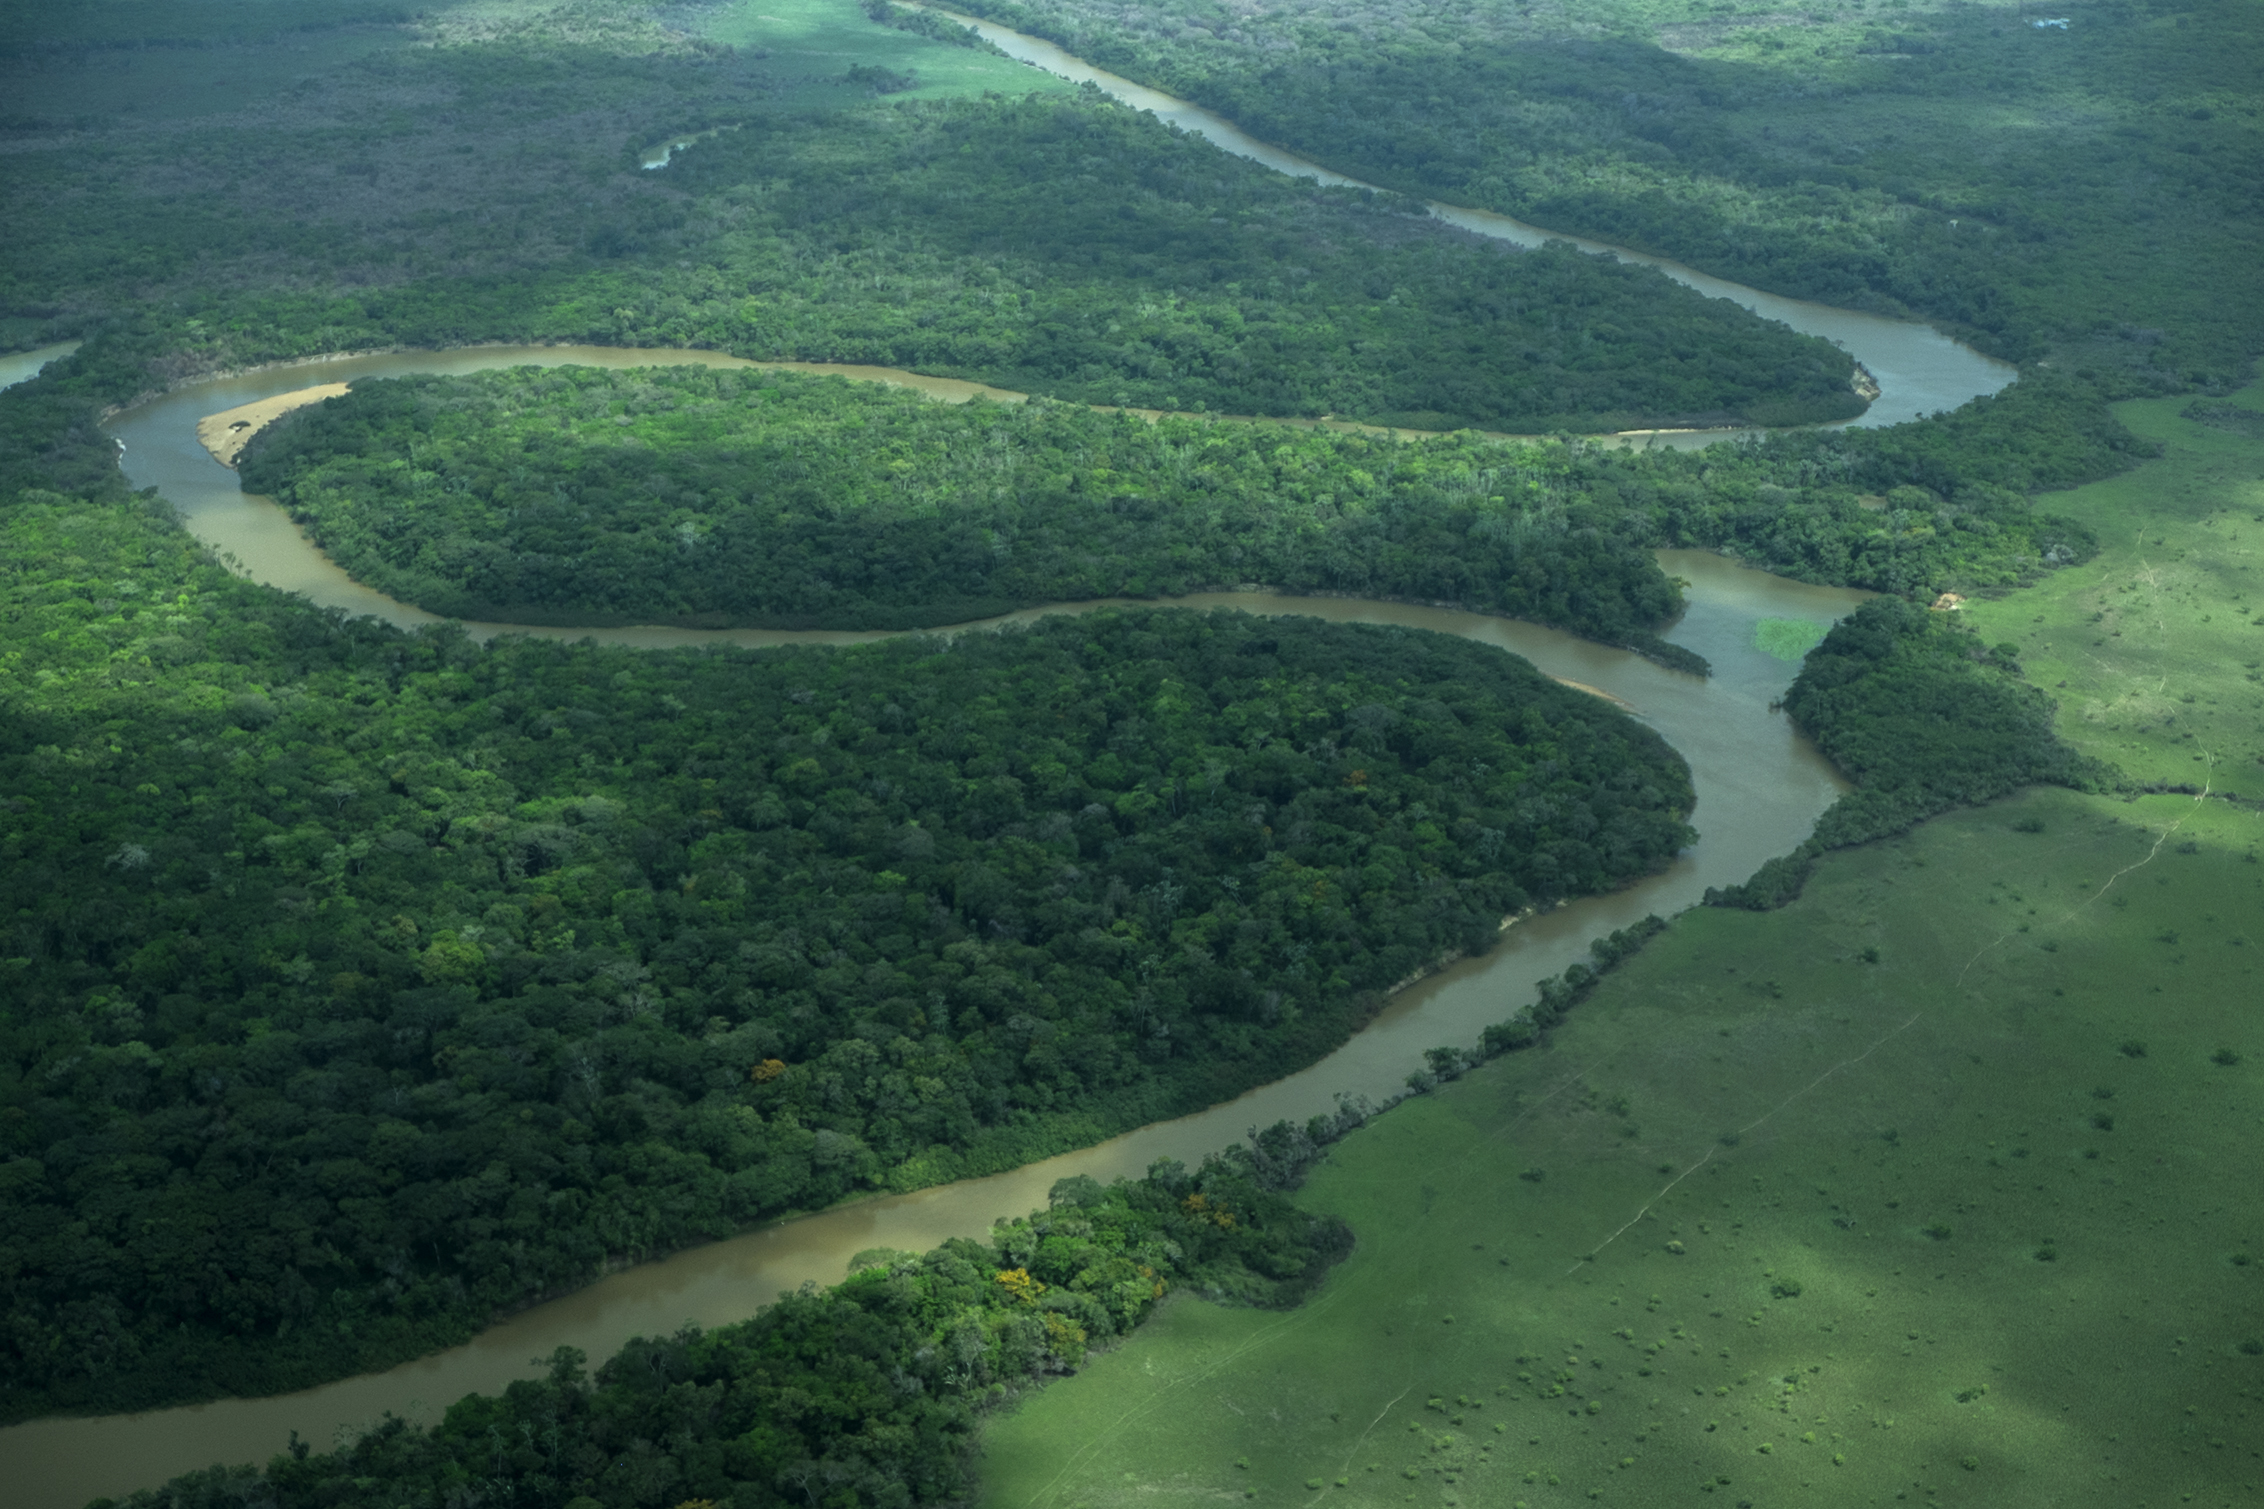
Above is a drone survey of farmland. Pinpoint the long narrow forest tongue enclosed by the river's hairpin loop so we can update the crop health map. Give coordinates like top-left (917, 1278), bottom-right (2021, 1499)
top-left (240, 369), bottom-right (1680, 645)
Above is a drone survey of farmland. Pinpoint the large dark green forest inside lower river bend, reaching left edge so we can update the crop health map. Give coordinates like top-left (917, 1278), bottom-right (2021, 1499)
top-left (0, 524), bottom-right (1691, 1414)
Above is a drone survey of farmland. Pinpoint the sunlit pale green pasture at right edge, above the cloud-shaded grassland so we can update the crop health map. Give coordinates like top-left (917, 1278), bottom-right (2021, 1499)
top-left (1965, 385), bottom-right (2264, 796)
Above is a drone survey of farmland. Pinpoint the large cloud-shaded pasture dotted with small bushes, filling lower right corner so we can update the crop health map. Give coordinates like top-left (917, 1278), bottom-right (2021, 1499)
top-left (983, 790), bottom-right (2264, 1509)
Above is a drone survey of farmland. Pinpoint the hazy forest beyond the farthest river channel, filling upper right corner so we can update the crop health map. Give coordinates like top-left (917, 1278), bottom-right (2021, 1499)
top-left (953, 0), bottom-right (2264, 394)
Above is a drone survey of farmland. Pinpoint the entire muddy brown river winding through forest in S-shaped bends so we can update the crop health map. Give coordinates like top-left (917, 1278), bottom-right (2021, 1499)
top-left (0, 18), bottom-right (2013, 1509)
